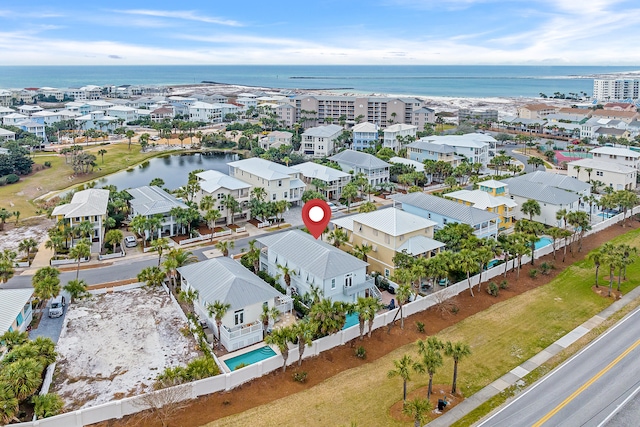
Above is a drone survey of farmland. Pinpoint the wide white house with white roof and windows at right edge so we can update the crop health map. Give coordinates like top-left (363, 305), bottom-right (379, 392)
top-left (567, 158), bottom-right (638, 191)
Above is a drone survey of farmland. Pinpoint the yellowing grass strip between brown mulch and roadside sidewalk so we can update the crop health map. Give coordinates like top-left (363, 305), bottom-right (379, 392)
top-left (208, 229), bottom-right (640, 426)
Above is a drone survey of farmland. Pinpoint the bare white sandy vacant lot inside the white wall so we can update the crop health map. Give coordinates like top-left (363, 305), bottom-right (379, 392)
top-left (52, 287), bottom-right (200, 411)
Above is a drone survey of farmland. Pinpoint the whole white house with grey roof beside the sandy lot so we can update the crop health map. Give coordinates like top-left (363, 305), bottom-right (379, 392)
top-left (178, 257), bottom-right (284, 351)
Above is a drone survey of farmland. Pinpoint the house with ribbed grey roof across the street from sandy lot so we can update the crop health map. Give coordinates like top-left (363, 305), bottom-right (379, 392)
top-left (125, 185), bottom-right (189, 239)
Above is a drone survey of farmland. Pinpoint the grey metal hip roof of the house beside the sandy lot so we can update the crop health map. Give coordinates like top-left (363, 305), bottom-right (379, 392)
top-left (178, 257), bottom-right (282, 310)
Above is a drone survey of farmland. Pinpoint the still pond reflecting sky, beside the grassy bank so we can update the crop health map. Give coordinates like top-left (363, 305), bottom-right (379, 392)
top-left (96, 153), bottom-right (239, 190)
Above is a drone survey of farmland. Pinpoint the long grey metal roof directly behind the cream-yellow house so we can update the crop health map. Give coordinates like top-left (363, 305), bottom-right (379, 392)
top-left (391, 193), bottom-right (498, 226)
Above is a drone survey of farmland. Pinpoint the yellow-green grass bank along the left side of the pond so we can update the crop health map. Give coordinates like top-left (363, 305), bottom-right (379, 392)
top-left (0, 143), bottom-right (175, 218)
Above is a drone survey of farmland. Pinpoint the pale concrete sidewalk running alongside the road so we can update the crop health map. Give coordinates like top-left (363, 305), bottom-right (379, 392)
top-left (427, 287), bottom-right (640, 427)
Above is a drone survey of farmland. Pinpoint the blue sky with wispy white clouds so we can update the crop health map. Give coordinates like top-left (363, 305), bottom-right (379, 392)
top-left (0, 0), bottom-right (640, 65)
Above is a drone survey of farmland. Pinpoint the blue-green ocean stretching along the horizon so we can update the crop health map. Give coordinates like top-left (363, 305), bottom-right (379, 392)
top-left (0, 65), bottom-right (640, 98)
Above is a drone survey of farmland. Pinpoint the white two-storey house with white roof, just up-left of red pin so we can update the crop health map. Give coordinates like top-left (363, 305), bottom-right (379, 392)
top-left (229, 157), bottom-right (306, 204)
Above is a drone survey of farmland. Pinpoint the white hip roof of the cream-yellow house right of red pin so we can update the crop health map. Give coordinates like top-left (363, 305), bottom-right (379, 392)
top-left (331, 208), bottom-right (437, 236)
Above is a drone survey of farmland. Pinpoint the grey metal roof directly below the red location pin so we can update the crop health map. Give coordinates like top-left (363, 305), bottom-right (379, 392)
top-left (257, 230), bottom-right (369, 280)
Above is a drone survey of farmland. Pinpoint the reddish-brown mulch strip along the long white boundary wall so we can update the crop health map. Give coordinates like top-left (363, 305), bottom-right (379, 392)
top-left (96, 222), bottom-right (639, 427)
